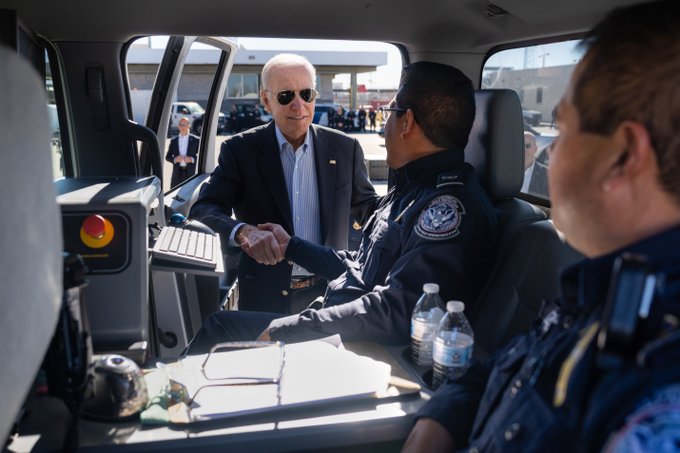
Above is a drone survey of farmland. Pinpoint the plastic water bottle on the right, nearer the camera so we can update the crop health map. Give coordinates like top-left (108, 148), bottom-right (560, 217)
top-left (432, 301), bottom-right (475, 388)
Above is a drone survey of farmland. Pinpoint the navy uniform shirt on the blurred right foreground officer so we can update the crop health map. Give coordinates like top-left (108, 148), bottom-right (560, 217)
top-left (416, 224), bottom-right (680, 452)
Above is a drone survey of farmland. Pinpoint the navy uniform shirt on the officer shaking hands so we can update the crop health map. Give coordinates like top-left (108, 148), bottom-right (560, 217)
top-left (269, 149), bottom-right (498, 344)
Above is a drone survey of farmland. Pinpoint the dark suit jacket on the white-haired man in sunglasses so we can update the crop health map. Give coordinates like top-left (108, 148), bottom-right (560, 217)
top-left (190, 122), bottom-right (378, 312)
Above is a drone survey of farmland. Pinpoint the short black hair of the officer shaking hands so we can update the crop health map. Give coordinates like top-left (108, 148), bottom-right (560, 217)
top-left (396, 61), bottom-right (475, 148)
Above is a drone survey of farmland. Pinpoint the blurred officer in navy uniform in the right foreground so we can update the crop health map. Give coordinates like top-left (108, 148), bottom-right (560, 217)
top-left (404, 0), bottom-right (680, 452)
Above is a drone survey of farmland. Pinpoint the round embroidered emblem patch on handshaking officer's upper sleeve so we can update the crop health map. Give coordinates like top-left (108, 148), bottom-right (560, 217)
top-left (415, 195), bottom-right (465, 240)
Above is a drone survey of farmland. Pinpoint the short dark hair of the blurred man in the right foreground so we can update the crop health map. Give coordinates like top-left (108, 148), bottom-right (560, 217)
top-left (573, 0), bottom-right (680, 203)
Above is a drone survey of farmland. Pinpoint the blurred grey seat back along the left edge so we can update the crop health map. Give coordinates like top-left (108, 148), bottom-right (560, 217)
top-left (0, 46), bottom-right (63, 445)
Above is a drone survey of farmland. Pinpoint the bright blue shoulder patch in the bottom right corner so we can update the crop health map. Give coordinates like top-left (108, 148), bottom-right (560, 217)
top-left (603, 384), bottom-right (680, 453)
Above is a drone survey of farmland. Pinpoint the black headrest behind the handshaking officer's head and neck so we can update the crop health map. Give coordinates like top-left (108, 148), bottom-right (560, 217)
top-left (465, 90), bottom-right (524, 200)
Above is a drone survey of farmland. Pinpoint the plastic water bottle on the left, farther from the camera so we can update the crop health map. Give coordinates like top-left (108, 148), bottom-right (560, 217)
top-left (411, 283), bottom-right (444, 366)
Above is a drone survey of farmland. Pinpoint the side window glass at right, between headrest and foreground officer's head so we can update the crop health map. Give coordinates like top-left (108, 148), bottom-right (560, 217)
top-left (481, 40), bottom-right (582, 199)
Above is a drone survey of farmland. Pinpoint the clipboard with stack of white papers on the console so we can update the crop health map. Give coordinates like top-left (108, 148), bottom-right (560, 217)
top-left (154, 338), bottom-right (420, 425)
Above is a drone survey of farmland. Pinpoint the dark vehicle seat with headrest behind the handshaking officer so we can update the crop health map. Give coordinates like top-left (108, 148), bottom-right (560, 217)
top-left (465, 90), bottom-right (581, 359)
